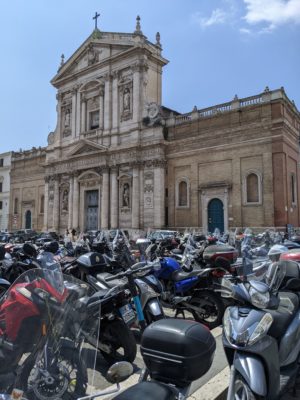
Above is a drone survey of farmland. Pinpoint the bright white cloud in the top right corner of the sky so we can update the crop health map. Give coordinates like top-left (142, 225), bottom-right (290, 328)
top-left (244, 0), bottom-right (300, 28)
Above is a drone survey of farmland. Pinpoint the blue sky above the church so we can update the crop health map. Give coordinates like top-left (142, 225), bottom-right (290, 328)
top-left (0, 0), bottom-right (300, 153)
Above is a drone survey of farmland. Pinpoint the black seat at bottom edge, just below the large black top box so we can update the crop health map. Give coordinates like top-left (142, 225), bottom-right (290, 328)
top-left (113, 381), bottom-right (177, 400)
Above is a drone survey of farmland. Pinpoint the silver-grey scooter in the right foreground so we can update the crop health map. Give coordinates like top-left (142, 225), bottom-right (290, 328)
top-left (222, 261), bottom-right (300, 400)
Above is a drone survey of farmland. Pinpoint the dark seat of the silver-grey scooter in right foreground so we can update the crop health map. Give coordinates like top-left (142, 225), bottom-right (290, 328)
top-left (267, 292), bottom-right (299, 339)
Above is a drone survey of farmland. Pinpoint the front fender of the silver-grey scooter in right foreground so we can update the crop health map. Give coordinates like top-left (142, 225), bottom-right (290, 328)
top-left (233, 352), bottom-right (267, 396)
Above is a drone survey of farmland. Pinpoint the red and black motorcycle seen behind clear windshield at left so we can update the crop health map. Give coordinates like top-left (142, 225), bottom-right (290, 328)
top-left (0, 253), bottom-right (99, 400)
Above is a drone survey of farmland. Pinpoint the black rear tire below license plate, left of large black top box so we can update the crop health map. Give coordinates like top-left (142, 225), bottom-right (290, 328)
top-left (99, 319), bottom-right (137, 364)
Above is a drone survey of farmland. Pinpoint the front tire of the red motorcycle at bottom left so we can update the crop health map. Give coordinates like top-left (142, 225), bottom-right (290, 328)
top-left (17, 347), bottom-right (87, 400)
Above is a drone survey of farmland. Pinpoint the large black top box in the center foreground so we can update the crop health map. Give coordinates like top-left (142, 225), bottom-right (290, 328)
top-left (141, 318), bottom-right (216, 387)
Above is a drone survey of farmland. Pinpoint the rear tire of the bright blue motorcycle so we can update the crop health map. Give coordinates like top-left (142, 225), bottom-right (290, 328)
top-left (189, 290), bottom-right (225, 329)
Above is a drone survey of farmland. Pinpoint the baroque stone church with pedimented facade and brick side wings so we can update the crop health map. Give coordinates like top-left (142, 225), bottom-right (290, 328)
top-left (10, 17), bottom-right (300, 232)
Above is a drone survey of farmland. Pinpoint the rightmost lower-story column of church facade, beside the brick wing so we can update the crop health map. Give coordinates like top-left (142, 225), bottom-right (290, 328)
top-left (153, 161), bottom-right (165, 228)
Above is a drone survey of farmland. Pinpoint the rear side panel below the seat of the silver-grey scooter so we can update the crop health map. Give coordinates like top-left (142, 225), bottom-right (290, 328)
top-left (279, 311), bottom-right (300, 367)
